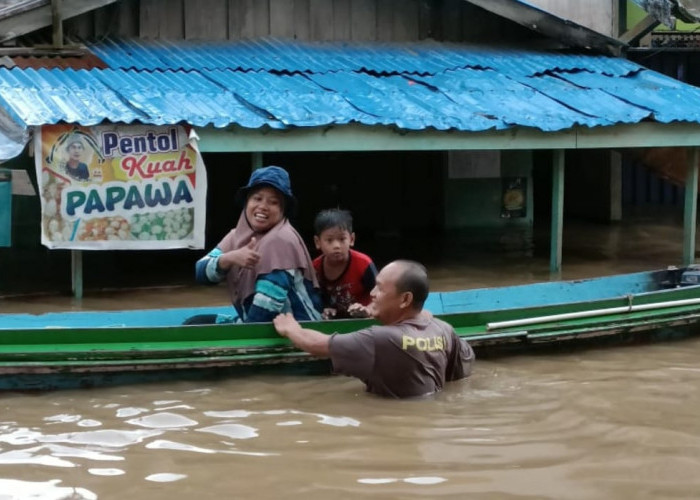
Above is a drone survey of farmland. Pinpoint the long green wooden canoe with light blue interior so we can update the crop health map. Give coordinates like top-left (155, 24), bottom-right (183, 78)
top-left (0, 268), bottom-right (700, 390)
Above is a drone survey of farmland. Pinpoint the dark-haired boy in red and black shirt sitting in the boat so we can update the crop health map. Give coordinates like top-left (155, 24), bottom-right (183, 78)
top-left (313, 208), bottom-right (377, 319)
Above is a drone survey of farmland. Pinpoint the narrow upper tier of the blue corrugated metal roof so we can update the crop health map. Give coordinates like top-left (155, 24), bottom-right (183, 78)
top-left (90, 38), bottom-right (639, 76)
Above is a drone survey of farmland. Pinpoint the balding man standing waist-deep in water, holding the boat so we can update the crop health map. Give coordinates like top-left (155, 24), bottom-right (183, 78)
top-left (274, 260), bottom-right (474, 398)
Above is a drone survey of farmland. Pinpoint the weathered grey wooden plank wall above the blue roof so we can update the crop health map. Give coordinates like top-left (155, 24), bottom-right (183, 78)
top-left (65, 0), bottom-right (531, 42)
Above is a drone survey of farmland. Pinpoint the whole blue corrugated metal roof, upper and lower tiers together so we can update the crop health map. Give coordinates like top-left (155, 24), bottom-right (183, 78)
top-left (0, 40), bottom-right (700, 131)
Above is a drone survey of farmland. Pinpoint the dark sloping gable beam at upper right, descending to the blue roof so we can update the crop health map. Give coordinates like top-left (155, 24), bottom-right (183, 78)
top-left (465, 0), bottom-right (626, 55)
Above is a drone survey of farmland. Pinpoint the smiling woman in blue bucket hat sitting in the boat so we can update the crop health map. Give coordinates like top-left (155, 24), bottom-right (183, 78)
top-left (191, 166), bottom-right (322, 324)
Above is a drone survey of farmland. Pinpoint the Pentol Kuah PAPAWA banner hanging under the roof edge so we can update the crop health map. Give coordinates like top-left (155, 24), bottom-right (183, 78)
top-left (34, 125), bottom-right (207, 250)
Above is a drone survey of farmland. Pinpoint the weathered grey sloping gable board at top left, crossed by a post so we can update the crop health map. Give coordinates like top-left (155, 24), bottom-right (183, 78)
top-left (0, 0), bottom-right (118, 42)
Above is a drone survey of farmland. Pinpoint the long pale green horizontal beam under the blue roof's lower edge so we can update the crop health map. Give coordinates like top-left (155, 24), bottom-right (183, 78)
top-left (197, 123), bottom-right (700, 153)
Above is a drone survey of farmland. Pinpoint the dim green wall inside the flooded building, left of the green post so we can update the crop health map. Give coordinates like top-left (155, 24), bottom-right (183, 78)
top-left (444, 151), bottom-right (534, 229)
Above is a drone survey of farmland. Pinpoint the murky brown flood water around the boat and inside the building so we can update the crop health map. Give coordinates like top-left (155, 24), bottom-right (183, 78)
top-left (0, 217), bottom-right (700, 500)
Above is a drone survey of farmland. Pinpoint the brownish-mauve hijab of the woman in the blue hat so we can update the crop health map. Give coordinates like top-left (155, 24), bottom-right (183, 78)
top-left (217, 210), bottom-right (318, 304)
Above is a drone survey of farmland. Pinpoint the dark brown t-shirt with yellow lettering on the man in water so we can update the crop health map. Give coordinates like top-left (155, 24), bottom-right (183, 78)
top-left (329, 316), bottom-right (474, 398)
